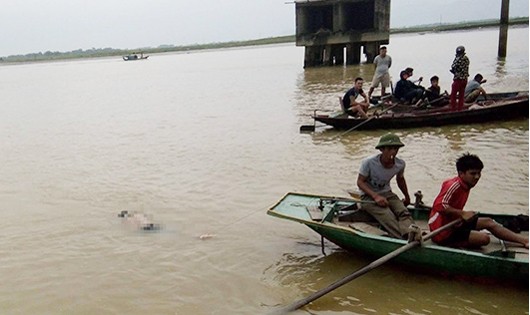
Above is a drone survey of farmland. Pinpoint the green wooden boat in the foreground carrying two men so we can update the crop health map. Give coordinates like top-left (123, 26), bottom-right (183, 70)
top-left (267, 193), bottom-right (528, 286)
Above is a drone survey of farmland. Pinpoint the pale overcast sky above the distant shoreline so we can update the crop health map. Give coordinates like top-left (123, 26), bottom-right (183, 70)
top-left (0, 0), bottom-right (528, 56)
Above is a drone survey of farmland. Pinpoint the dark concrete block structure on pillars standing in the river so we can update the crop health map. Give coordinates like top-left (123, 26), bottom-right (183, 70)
top-left (295, 0), bottom-right (390, 68)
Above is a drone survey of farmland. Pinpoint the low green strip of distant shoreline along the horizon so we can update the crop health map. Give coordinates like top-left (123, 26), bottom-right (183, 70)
top-left (0, 17), bottom-right (528, 64)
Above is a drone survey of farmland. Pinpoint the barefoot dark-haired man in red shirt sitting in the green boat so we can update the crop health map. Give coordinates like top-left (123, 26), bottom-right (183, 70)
top-left (429, 153), bottom-right (528, 248)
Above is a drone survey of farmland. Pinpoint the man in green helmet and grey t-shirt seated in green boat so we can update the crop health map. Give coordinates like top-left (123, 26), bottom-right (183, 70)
top-left (357, 133), bottom-right (414, 239)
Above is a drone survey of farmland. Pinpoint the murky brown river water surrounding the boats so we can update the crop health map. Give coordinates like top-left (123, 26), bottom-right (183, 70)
top-left (0, 27), bottom-right (529, 314)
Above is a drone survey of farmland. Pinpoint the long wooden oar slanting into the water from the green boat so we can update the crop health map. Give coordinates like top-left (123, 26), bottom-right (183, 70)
top-left (274, 218), bottom-right (463, 314)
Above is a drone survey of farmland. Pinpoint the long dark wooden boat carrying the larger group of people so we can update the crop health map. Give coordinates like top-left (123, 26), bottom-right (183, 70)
top-left (313, 91), bottom-right (528, 130)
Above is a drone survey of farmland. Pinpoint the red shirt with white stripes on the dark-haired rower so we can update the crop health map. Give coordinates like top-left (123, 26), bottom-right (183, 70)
top-left (429, 176), bottom-right (470, 243)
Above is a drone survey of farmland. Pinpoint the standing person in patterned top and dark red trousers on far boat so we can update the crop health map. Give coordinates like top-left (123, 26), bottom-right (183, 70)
top-left (449, 46), bottom-right (469, 111)
